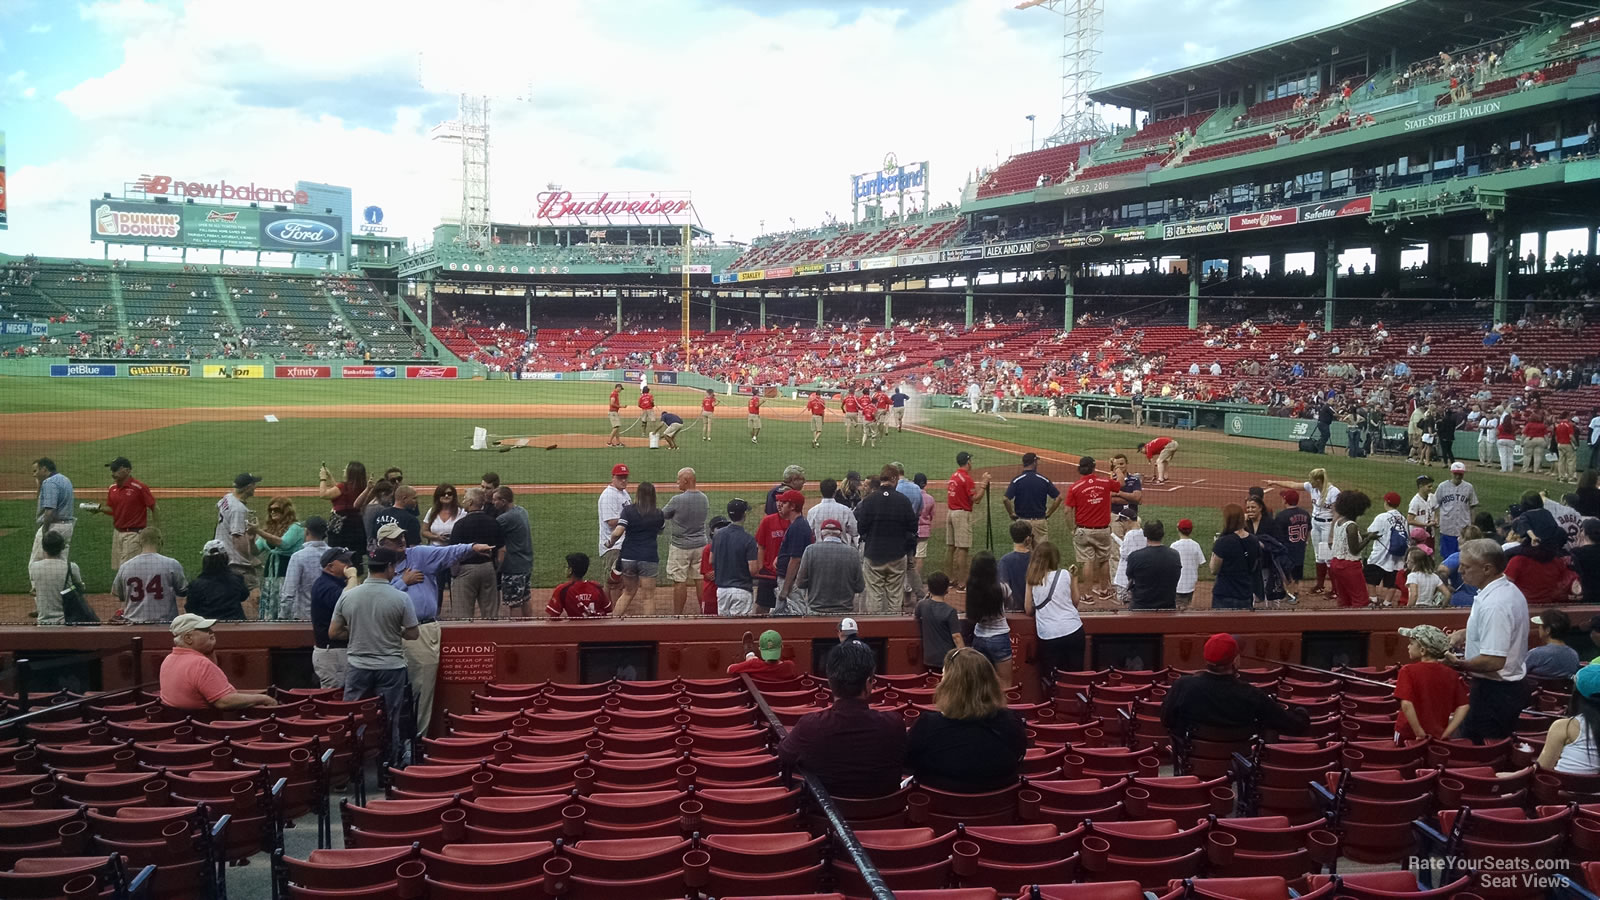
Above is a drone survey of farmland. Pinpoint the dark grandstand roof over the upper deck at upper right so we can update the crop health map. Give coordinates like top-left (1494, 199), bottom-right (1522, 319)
top-left (1090, 0), bottom-right (1600, 109)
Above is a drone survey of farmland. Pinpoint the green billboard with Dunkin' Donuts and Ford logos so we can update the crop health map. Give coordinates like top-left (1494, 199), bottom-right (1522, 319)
top-left (90, 200), bottom-right (344, 253)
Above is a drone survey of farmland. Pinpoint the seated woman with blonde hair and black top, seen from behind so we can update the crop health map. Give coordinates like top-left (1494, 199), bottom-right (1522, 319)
top-left (906, 647), bottom-right (1027, 794)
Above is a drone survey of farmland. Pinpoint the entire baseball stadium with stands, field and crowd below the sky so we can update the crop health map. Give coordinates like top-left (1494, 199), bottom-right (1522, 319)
top-left (0, 0), bottom-right (1600, 900)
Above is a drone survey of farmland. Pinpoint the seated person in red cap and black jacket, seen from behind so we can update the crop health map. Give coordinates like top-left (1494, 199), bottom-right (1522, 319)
top-left (1162, 630), bottom-right (1310, 735)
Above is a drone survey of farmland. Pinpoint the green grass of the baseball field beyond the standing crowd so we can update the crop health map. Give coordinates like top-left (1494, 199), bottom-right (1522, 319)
top-left (0, 378), bottom-right (1555, 605)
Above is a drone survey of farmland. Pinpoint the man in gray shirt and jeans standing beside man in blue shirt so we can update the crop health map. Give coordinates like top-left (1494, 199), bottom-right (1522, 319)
top-left (328, 548), bottom-right (418, 764)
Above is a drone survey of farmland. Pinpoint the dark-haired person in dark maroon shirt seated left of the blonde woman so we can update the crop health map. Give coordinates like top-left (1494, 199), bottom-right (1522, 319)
top-left (778, 641), bottom-right (906, 798)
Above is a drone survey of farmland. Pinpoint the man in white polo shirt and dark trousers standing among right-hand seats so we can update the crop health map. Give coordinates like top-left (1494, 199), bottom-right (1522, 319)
top-left (1445, 540), bottom-right (1528, 743)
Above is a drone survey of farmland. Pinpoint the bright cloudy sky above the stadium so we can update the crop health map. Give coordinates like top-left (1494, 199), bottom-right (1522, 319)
top-left (0, 0), bottom-right (1394, 256)
